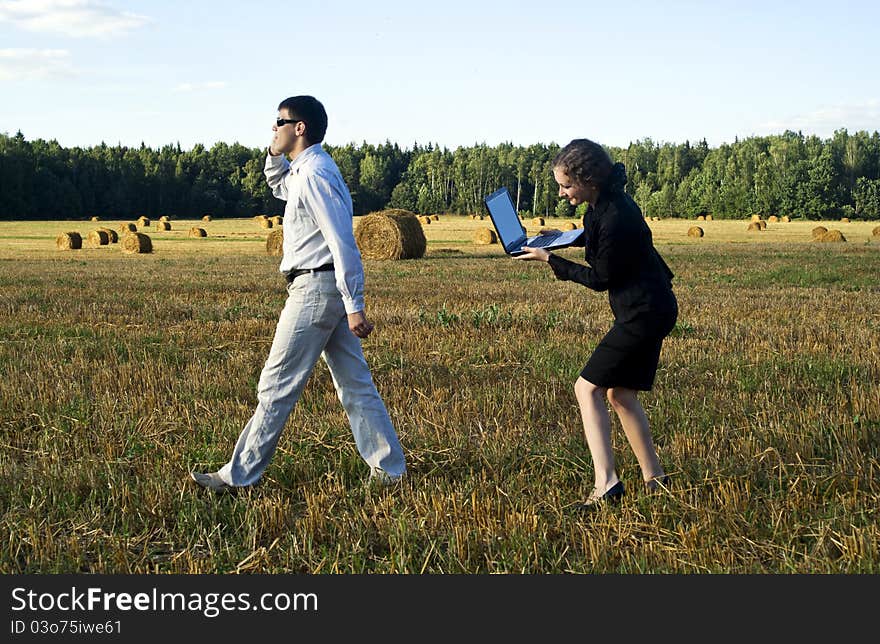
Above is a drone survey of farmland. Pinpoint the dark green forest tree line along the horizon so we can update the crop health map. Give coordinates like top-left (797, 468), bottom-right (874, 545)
top-left (0, 129), bottom-right (880, 220)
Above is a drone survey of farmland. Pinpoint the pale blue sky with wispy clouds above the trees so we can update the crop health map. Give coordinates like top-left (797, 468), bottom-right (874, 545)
top-left (0, 0), bottom-right (880, 149)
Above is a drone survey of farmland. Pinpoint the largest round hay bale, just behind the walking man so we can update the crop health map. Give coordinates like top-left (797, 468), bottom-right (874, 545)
top-left (354, 209), bottom-right (427, 259)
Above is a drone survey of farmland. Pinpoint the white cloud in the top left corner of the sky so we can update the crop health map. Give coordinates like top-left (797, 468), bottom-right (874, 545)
top-left (0, 0), bottom-right (150, 38)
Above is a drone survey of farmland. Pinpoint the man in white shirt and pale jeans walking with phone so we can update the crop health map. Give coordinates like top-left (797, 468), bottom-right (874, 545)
top-left (191, 96), bottom-right (406, 492)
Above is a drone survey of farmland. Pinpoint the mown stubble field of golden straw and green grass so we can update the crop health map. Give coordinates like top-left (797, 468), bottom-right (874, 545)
top-left (0, 215), bottom-right (880, 574)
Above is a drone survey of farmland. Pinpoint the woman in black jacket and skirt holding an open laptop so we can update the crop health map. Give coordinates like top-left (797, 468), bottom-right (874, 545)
top-left (518, 139), bottom-right (678, 510)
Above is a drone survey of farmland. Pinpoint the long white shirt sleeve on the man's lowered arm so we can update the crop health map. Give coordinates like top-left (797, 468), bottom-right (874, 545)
top-left (298, 172), bottom-right (364, 313)
